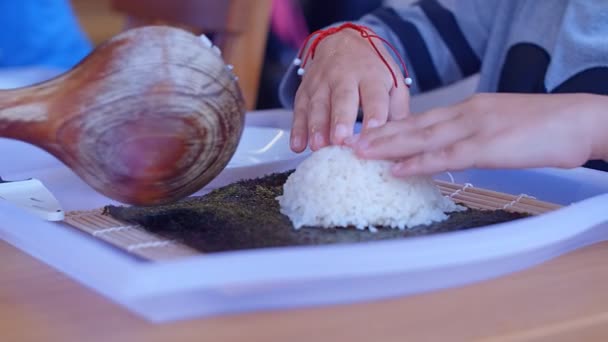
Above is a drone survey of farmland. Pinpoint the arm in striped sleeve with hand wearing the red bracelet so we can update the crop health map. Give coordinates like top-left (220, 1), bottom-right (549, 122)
top-left (280, 0), bottom-right (497, 151)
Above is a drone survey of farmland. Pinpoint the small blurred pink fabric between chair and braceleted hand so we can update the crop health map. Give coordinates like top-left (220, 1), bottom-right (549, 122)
top-left (270, 0), bottom-right (309, 49)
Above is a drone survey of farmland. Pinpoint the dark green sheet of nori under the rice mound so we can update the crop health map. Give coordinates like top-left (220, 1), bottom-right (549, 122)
top-left (104, 172), bottom-right (527, 253)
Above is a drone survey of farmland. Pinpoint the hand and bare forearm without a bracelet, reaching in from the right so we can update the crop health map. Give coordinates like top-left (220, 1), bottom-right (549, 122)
top-left (347, 94), bottom-right (608, 176)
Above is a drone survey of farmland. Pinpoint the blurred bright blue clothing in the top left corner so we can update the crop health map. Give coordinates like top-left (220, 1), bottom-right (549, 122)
top-left (0, 0), bottom-right (92, 69)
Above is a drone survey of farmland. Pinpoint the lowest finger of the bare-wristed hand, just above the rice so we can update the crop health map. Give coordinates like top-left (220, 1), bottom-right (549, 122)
top-left (392, 138), bottom-right (484, 177)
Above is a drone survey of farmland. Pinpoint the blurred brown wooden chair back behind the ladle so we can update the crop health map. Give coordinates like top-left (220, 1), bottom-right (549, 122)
top-left (111, 0), bottom-right (272, 109)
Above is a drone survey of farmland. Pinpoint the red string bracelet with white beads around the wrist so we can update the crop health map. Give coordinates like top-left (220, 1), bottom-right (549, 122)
top-left (293, 23), bottom-right (412, 88)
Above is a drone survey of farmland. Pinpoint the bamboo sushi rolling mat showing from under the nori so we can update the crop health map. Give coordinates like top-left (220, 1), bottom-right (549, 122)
top-left (64, 181), bottom-right (561, 261)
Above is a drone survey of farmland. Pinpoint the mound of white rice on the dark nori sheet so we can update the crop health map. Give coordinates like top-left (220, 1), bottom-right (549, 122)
top-left (277, 146), bottom-right (462, 231)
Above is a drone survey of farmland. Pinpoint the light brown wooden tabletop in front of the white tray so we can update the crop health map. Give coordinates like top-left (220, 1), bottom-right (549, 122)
top-left (0, 241), bottom-right (608, 342)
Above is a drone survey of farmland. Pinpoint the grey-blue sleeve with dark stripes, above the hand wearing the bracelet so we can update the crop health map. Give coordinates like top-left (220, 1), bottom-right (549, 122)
top-left (279, 0), bottom-right (500, 108)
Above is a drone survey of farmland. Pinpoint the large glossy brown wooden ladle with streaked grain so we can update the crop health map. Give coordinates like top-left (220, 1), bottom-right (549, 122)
top-left (0, 26), bottom-right (245, 205)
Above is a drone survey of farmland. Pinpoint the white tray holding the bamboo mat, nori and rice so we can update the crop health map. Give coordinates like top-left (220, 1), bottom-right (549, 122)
top-left (0, 111), bottom-right (608, 322)
